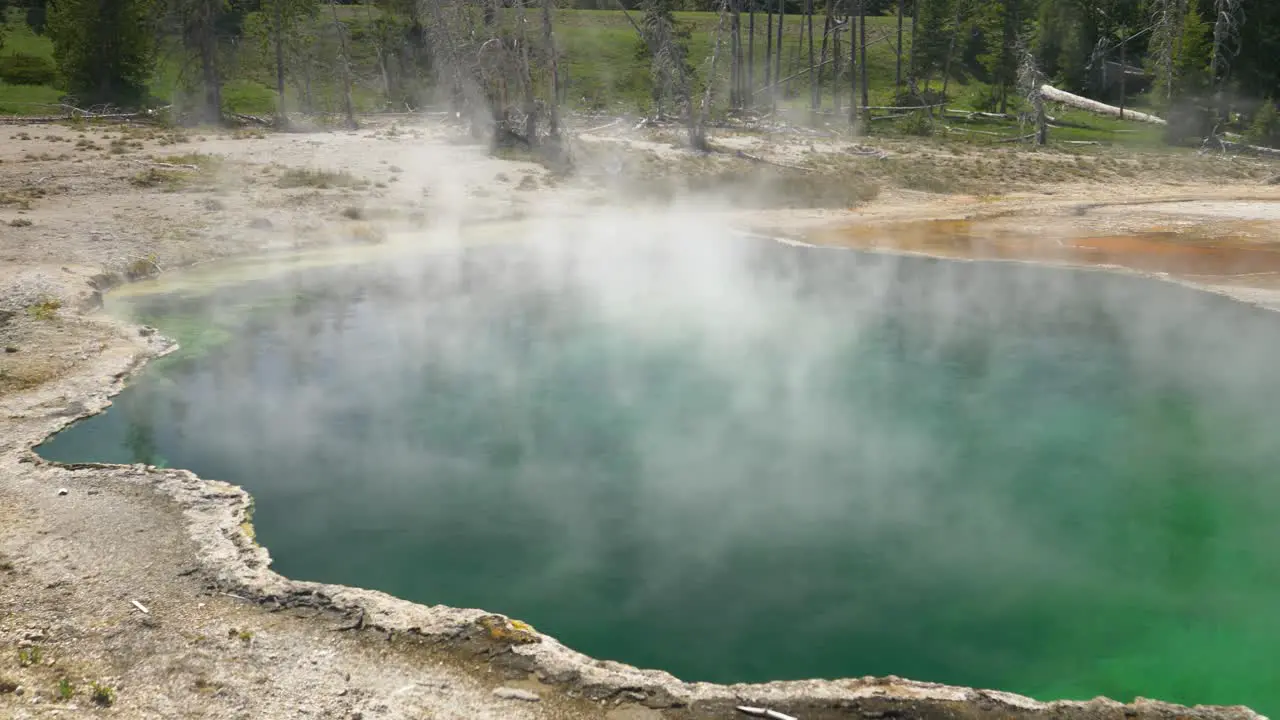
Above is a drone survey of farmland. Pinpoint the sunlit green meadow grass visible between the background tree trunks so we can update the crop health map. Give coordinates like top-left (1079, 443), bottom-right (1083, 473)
top-left (0, 5), bottom-right (1177, 151)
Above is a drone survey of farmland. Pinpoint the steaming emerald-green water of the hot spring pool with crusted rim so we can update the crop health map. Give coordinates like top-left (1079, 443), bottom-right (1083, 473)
top-left (41, 237), bottom-right (1280, 712)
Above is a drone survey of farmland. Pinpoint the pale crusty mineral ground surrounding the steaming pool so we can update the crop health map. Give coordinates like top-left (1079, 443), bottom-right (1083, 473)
top-left (0, 114), bottom-right (1280, 720)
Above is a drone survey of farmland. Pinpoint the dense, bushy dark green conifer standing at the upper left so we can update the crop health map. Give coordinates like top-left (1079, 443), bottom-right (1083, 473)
top-left (47, 0), bottom-right (156, 106)
